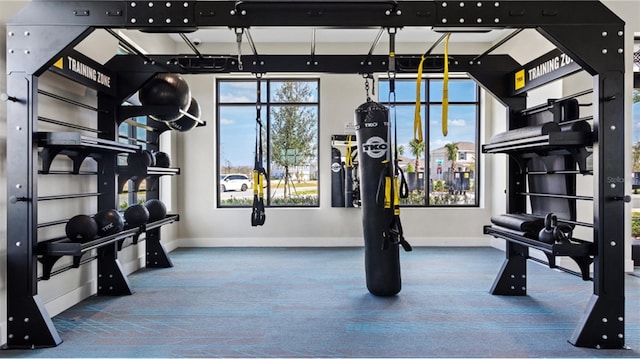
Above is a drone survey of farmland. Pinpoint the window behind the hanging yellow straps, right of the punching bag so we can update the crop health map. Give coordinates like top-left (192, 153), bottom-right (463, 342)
top-left (379, 78), bottom-right (480, 206)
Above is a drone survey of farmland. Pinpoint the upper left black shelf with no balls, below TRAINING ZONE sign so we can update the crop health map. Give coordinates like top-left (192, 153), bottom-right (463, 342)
top-left (37, 132), bottom-right (140, 174)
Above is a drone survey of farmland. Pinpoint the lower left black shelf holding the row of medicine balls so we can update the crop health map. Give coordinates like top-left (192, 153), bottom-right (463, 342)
top-left (36, 214), bottom-right (179, 280)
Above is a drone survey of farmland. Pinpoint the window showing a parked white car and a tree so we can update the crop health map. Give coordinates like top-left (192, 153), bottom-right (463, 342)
top-left (215, 79), bottom-right (319, 207)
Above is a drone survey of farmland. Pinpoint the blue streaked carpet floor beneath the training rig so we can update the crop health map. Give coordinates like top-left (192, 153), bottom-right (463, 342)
top-left (0, 248), bottom-right (640, 358)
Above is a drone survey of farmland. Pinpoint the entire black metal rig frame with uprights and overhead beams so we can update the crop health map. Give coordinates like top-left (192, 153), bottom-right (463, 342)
top-left (7, 0), bottom-right (631, 348)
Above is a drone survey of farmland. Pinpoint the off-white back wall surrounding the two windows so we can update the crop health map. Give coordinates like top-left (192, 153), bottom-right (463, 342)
top-left (178, 42), bottom-right (493, 246)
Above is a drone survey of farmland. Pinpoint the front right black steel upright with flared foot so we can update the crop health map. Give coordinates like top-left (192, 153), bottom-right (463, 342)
top-left (569, 71), bottom-right (625, 348)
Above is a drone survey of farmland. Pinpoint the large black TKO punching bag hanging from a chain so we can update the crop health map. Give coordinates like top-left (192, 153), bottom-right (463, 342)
top-left (355, 101), bottom-right (401, 296)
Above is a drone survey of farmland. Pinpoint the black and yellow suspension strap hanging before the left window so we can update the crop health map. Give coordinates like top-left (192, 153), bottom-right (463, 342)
top-left (251, 73), bottom-right (267, 227)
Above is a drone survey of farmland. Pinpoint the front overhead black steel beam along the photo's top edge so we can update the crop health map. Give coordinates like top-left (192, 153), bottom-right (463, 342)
top-left (10, 0), bottom-right (619, 32)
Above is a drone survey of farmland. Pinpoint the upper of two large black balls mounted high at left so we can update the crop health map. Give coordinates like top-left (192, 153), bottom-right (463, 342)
top-left (138, 74), bottom-right (191, 122)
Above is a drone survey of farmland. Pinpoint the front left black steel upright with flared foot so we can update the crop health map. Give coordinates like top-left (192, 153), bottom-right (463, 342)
top-left (6, 72), bottom-right (62, 348)
